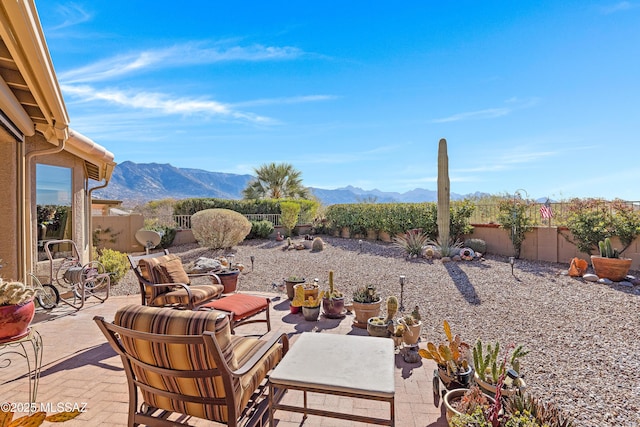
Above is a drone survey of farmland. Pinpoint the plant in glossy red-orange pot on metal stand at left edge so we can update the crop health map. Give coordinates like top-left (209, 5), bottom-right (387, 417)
top-left (0, 279), bottom-right (36, 341)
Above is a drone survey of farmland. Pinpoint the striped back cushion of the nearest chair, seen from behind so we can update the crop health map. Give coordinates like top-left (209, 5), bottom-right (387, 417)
top-left (114, 305), bottom-right (241, 423)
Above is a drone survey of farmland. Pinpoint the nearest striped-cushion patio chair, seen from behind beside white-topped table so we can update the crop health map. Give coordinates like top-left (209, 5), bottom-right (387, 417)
top-left (94, 305), bottom-right (289, 427)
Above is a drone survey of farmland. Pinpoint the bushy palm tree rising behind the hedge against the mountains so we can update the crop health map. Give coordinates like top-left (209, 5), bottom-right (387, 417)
top-left (242, 163), bottom-right (310, 199)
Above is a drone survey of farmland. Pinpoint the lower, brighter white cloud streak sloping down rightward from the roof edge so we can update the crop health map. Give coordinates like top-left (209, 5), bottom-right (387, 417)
top-left (61, 85), bottom-right (274, 124)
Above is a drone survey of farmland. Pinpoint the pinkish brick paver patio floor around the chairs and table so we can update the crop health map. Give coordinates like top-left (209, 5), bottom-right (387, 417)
top-left (0, 294), bottom-right (447, 427)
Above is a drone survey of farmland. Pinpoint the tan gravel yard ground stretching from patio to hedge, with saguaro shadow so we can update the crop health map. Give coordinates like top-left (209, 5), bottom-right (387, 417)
top-left (112, 236), bottom-right (640, 427)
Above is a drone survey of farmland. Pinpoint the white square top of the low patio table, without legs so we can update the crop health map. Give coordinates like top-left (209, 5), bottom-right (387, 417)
top-left (269, 332), bottom-right (395, 397)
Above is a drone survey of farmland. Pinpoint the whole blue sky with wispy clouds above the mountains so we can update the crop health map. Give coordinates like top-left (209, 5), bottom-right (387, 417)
top-left (36, 0), bottom-right (640, 200)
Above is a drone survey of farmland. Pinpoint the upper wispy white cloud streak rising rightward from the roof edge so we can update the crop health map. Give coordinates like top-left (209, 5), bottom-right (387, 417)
top-left (58, 43), bottom-right (303, 84)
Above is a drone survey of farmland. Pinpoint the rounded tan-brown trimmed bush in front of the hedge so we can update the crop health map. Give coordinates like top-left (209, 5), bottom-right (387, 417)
top-left (191, 209), bottom-right (251, 249)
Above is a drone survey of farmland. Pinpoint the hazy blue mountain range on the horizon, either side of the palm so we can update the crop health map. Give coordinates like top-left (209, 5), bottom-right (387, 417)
top-left (94, 161), bottom-right (478, 207)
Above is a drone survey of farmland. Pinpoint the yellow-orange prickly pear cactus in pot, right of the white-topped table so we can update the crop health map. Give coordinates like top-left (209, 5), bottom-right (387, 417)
top-left (418, 320), bottom-right (473, 390)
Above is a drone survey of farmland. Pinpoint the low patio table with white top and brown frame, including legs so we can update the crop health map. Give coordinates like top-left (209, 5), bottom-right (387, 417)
top-left (269, 332), bottom-right (395, 426)
